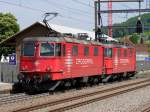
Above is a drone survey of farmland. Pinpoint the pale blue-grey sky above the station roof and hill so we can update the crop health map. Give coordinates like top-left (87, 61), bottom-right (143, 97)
top-left (0, 0), bottom-right (146, 30)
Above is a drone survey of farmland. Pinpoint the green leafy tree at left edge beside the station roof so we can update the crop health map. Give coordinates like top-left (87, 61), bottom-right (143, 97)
top-left (0, 13), bottom-right (20, 57)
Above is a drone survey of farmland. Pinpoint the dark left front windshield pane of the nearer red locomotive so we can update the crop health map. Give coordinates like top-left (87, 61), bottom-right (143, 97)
top-left (22, 42), bottom-right (35, 56)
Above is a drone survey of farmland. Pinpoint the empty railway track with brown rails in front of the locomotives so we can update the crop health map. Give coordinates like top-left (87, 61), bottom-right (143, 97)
top-left (13, 79), bottom-right (150, 112)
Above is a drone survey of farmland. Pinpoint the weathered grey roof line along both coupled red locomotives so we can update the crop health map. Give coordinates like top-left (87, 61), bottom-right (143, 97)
top-left (23, 37), bottom-right (133, 48)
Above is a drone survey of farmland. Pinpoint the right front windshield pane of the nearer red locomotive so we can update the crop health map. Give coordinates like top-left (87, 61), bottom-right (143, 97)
top-left (40, 43), bottom-right (54, 56)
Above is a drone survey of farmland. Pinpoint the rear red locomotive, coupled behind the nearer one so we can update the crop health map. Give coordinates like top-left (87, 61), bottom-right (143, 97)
top-left (104, 44), bottom-right (136, 81)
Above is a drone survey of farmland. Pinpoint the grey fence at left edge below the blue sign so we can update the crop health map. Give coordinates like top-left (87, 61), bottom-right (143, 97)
top-left (0, 62), bottom-right (19, 83)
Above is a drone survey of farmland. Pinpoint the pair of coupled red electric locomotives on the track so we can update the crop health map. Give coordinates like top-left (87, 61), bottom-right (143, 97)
top-left (14, 37), bottom-right (136, 91)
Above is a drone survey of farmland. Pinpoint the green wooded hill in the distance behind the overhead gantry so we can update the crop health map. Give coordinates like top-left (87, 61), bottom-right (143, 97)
top-left (103, 13), bottom-right (150, 38)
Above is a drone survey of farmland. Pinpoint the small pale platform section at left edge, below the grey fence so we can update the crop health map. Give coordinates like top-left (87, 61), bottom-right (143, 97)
top-left (0, 82), bottom-right (12, 94)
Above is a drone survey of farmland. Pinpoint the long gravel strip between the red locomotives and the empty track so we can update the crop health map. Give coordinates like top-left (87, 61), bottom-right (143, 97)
top-left (0, 79), bottom-right (146, 112)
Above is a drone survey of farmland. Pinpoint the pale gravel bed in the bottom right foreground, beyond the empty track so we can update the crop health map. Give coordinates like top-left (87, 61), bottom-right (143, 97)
top-left (65, 86), bottom-right (150, 112)
